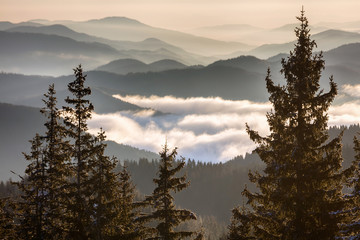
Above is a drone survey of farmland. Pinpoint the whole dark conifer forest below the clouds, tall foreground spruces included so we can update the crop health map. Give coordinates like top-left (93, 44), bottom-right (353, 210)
top-left (0, 11), bottom-right (360, 240)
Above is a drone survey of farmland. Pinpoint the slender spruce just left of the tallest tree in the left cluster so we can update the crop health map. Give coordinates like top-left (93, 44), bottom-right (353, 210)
top-left (40, 84), bottom-right (71, 238)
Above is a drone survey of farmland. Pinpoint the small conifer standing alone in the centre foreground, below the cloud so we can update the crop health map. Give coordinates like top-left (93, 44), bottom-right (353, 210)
top-left (145, 144), bottom-right (196, 240)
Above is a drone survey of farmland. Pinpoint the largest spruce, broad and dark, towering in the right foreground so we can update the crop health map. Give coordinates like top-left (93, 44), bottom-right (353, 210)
top-left (233, 11), bottom-right (351, 239)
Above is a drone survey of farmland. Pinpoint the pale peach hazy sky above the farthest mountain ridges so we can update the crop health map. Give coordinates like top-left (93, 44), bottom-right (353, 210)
top-left (0, 0), bottom-right (360, 30)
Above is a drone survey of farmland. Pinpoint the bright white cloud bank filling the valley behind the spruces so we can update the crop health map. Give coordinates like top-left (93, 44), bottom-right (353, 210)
top-left (89, 94), bottom-right (360, 162)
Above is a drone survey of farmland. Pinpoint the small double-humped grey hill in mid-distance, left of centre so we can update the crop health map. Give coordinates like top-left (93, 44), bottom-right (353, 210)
top-left (97, 59), bottom-right (187, 74)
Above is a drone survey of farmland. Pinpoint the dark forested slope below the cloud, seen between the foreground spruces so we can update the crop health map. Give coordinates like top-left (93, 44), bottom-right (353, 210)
top-left (126, 125), bottom-right (360, 226)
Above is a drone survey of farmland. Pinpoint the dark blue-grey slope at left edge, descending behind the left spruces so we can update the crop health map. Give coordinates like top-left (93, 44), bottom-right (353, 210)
top-left (0, 103), bottom-right (158, 181)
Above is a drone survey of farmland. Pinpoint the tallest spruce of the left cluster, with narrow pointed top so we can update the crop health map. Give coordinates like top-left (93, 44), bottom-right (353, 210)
top-left (63, 65), bottom-right (94, 239)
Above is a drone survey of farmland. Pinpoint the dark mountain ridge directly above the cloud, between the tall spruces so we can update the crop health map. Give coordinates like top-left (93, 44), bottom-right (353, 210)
top-left (88, 66), bottom-right (268, 101)
